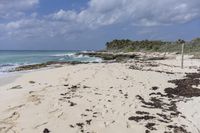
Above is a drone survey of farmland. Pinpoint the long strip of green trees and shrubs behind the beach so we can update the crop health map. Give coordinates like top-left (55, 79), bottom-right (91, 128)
top-left (106, 38), bottom-right (200, 53)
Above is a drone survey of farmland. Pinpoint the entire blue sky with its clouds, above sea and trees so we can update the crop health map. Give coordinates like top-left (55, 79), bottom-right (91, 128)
top-left (0, 0), bottom-right (200, 50)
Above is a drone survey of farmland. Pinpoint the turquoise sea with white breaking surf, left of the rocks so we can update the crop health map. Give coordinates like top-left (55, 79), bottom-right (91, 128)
top-left (0, 51), bottom-right (101, 73)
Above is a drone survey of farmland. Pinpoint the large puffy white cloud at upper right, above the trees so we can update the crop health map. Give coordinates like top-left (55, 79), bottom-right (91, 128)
top-left (48, 0), bottom-right (200, 28)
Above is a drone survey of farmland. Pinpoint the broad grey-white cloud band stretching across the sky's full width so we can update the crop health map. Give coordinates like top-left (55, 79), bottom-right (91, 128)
top-left (0, 0), bottom-right (200, 39)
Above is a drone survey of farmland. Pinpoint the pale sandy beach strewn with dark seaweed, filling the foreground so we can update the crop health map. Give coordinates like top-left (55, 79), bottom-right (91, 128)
top-left (0, 54), bottom-right (200, 133)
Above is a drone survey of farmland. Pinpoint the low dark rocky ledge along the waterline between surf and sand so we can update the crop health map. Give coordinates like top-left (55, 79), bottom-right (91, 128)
top-left (9, 52), bottom-right (167, 72)
